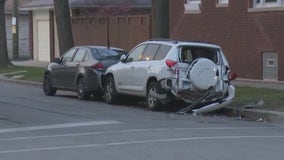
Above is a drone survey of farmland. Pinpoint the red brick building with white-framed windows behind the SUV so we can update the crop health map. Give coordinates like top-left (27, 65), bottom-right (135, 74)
top-left (169, 0), bottom-right (284, 81)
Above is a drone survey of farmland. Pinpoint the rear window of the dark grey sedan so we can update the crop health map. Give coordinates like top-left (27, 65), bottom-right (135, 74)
top-left (91, 48), bottom-right (120, 59)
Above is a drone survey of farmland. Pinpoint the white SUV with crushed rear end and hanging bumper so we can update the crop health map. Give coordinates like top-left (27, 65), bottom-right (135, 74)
top-left (102, 40), bottom-right (236, 114)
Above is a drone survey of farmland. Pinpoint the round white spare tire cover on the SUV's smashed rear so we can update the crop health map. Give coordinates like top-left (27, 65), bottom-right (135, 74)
top-left (188, 58), bottom-right (218, 90)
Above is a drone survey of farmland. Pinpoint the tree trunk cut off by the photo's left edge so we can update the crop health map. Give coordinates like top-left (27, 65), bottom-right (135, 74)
top-left (0, 0), bottom-right (12, 66)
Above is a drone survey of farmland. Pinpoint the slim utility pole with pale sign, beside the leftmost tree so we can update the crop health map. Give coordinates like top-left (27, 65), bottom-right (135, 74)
top-left (12, 0), bottom-right (19, 59)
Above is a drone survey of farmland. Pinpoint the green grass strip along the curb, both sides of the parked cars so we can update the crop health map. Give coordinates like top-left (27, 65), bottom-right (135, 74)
top-left (0, 66), bottom-right (284, 112)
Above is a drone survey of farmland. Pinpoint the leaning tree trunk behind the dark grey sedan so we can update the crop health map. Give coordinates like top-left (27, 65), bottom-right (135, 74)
top-left (54, 0), bottom-right (73, 55)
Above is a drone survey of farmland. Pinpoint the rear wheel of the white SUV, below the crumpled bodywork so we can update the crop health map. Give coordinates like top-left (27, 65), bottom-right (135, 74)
top-left (147, 82), bottom-right (161, 111)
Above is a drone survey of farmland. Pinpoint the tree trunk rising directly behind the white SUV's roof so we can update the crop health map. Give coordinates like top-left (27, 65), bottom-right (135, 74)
top-left (152, 0), bottom-right (169, 38)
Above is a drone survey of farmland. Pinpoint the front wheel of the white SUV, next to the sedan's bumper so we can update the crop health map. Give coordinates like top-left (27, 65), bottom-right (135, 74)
top-left (104, 77), bottom-right (117, 104)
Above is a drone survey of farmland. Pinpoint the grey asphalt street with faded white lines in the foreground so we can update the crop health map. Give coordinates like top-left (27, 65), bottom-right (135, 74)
top-left (0, 82), bottom-right (284, 160)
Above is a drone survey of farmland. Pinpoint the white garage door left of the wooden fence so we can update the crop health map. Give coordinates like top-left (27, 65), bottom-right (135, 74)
top-left (37, 20), bottom-right (50, 62)
